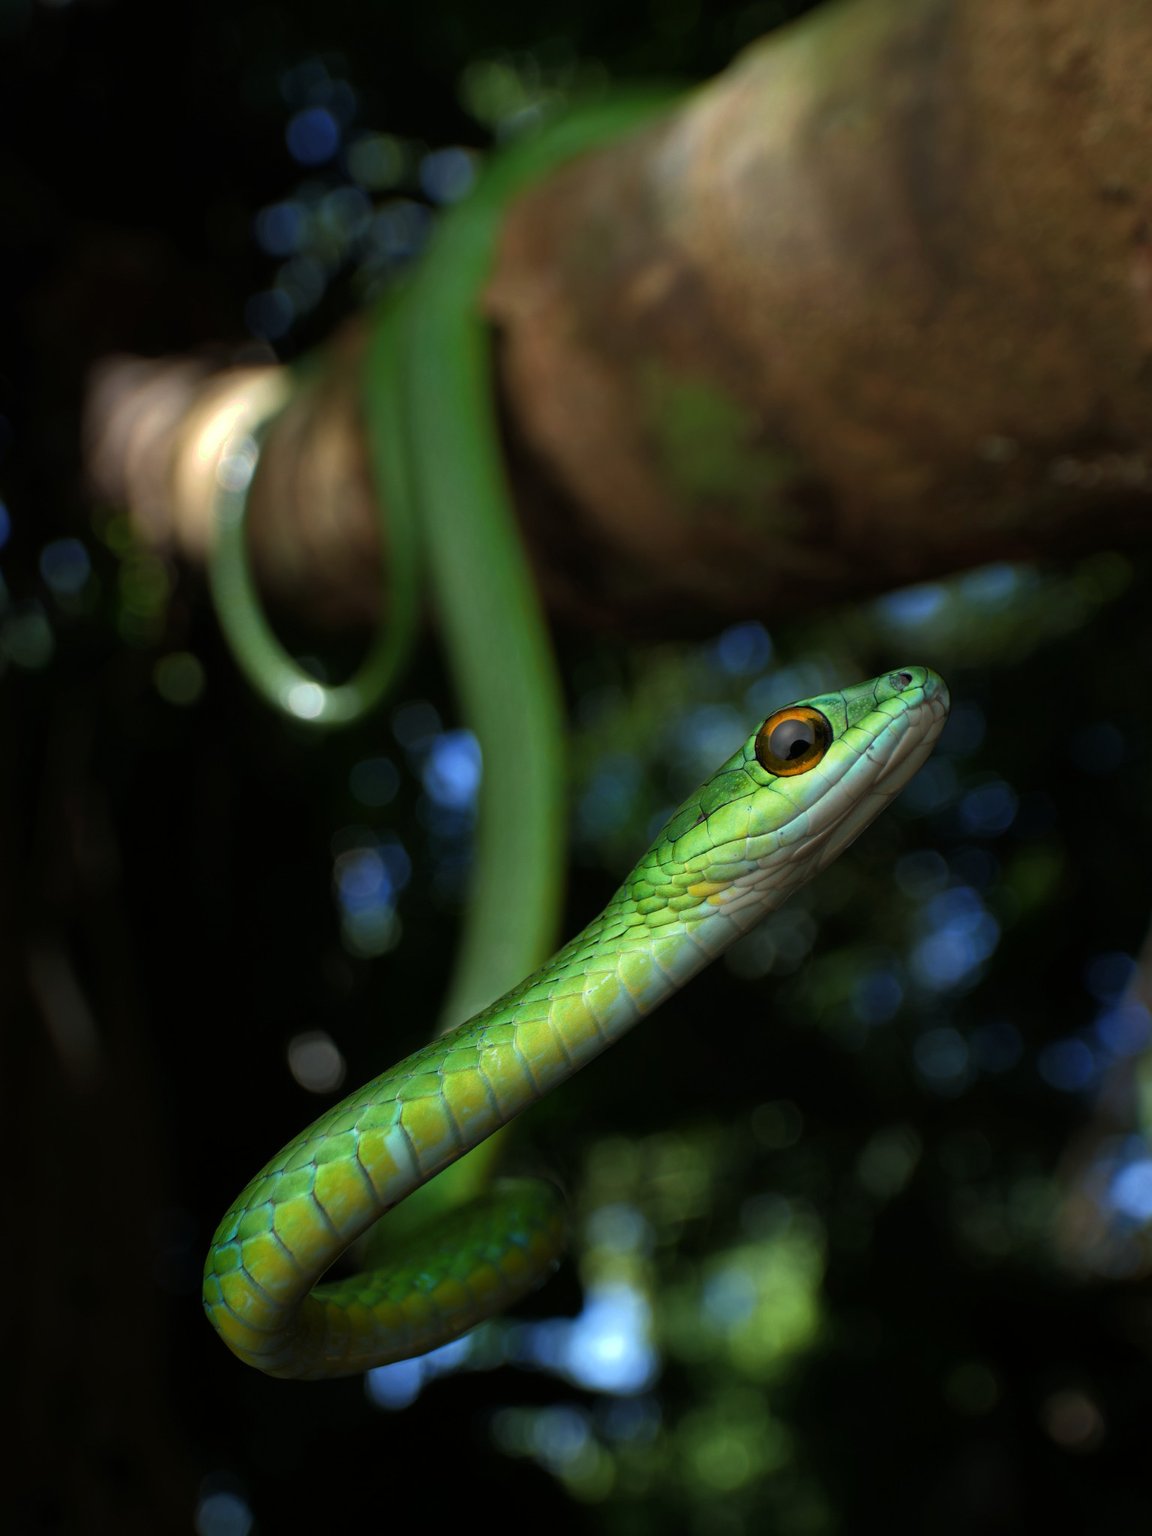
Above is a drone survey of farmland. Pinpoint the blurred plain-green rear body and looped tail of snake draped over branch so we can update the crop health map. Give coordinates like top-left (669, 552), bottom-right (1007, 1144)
top-left (209, 89), bottom-right (691, 1271)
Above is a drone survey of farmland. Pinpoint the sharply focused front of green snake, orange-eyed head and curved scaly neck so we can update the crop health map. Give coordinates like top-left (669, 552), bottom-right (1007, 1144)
top-left (204, 667), bottom-right (948, 1379)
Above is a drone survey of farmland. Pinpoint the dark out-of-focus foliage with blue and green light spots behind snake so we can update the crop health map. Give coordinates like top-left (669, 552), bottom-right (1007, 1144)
top-left (0, 0), bottom-right (1152, 1536)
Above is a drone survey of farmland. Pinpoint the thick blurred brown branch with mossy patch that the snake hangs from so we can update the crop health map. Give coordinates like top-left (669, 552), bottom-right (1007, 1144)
top-left (85, 0), bottom-right (1152, 631)
